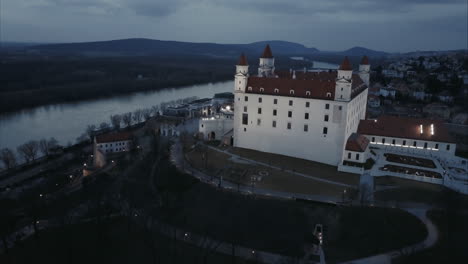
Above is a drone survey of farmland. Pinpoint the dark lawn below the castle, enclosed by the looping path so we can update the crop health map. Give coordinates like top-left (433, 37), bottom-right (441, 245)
top-left (163, 170), bottom-right (426, 263)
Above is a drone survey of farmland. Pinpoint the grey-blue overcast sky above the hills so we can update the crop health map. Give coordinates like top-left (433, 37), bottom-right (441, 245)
top-left (0, 0), bottom-right (468, 51)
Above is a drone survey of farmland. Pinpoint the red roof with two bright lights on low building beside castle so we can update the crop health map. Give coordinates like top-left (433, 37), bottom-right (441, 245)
top-left (358, 116), bottom-right (455, 143)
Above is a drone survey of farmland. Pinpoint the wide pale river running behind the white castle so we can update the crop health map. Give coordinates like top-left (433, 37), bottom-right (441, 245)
top-left (0, 61), bottom-right (337, 153)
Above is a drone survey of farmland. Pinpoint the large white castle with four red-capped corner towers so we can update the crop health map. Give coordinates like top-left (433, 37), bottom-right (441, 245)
top-left (233, 45), bottom-right (370, 166)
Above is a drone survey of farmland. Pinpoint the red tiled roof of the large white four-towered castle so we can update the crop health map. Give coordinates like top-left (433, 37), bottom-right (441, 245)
top-left (246, 71), bottom-right (367, 100)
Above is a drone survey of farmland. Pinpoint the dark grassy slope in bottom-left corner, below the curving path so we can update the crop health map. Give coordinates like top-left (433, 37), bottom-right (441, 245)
top-left (0, 218), bottom-right (256, 264)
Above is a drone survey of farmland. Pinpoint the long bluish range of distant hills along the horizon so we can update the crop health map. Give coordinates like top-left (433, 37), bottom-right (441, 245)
top-left (25, 38), bottom-right (389, 57)
